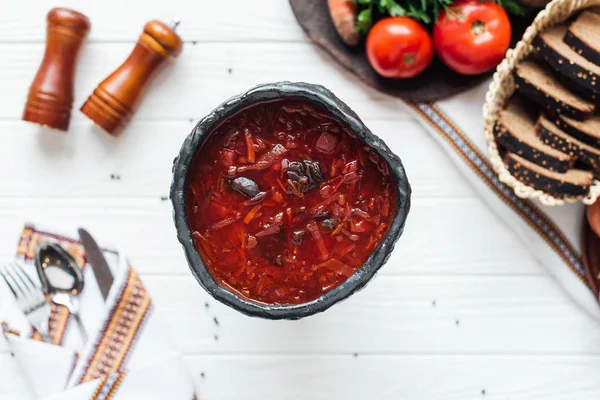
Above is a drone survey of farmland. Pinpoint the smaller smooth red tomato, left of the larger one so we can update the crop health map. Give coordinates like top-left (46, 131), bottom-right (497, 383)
top-left (367, 17), bottom-right (433, 78)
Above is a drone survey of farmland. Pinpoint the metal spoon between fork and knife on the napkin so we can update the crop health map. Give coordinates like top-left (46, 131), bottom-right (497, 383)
top-left (35, 241), bottom-right (87, 343)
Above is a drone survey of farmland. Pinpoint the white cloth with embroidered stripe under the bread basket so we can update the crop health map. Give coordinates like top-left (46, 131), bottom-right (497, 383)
top-left (409, 81), bottom-right (600, 320)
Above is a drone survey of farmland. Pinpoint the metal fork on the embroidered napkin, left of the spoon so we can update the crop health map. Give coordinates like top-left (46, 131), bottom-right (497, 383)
top-left (0, 263), bottom-right (52, 342)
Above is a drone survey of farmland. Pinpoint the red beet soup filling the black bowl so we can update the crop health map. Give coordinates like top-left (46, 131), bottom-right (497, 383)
top-left (185, 100), bottom-right (397, 304)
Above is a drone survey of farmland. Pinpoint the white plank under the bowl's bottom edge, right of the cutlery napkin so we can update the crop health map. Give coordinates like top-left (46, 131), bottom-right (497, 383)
top-left (138, 276), bottom-right (600, 355)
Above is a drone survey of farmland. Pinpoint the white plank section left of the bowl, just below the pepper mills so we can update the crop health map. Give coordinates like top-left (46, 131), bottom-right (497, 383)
top-left (0, 120), bottom-right (195, 200)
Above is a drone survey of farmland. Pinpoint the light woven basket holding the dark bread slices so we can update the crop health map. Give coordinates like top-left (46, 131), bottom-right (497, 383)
top-left (483, 0), bottom-right (600, 206)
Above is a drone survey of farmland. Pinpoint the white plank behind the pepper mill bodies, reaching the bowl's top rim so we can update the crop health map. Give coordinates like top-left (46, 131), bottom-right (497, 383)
top-left (0, 41), bottom-right (412, 122)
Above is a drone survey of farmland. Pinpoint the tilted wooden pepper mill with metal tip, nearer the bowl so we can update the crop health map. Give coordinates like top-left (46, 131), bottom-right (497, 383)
top-left (81, 19), bottom-right (183, 136)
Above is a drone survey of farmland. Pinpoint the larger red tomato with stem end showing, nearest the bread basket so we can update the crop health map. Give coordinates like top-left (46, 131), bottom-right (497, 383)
top-left (433, 0), bottom-right (511, 75)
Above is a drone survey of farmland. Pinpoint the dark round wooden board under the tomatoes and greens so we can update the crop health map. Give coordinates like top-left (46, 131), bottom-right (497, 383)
top-left (290, 0), bottom-right (535, 102)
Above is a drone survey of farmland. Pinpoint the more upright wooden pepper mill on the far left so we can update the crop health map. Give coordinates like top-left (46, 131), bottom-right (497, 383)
top-left (23, 8), bottom-right (90, 131)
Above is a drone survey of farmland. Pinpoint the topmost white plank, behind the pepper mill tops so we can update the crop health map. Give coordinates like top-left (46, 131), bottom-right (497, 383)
top-left (0, 0), bottom-right (306, 43)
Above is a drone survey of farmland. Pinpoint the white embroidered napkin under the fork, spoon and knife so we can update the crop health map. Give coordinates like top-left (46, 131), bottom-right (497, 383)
top-left (0, 225), bottom-right (196, 400)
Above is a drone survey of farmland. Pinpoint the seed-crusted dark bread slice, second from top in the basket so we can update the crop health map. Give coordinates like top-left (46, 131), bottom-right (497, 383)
top-left (532, 24), bottom-right (600, 93)
